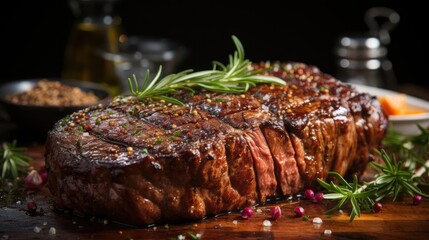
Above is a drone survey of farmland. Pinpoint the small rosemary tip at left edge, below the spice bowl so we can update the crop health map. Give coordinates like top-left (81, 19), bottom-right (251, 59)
top-left (0, 140), bottom-right (31, 179)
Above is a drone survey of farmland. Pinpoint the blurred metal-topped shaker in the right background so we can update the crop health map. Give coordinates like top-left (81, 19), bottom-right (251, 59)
top-left (334, 7), bottom-right (400, 89)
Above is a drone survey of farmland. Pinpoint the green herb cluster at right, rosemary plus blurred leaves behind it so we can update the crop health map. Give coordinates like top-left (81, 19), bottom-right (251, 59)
top-left (317, 126), bottom-right (429, 221)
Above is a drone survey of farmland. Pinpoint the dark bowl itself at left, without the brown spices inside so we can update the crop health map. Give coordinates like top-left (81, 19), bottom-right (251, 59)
top-left (0, 79), bottom-right (112, 141)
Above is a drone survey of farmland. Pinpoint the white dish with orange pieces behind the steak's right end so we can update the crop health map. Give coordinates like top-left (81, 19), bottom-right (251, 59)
top-left (352, 84), bottom-right (429, 135)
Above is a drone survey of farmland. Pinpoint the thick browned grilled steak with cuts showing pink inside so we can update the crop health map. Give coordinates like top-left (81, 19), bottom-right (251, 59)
top-left (46, 62), bottom-right (388, 226)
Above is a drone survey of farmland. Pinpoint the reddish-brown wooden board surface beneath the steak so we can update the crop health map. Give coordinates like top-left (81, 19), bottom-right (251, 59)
top-left (0, 145), bottom-right (429, 239)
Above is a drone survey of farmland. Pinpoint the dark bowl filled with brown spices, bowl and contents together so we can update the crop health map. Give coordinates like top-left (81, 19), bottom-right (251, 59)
top-left (0, 79), bottom-right (111, 141)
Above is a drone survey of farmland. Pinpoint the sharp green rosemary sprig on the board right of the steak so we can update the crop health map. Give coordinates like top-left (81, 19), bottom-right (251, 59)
top-left (317, 140), bottom-right (429, 222)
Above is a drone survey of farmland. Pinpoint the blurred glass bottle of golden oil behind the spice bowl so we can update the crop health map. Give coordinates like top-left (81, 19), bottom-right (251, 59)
top-left (62, 0), bottom-right (123, 96)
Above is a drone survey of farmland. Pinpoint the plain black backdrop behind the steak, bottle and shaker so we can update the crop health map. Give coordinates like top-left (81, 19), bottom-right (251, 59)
top-left (0, 0), bottom-right (429, 94)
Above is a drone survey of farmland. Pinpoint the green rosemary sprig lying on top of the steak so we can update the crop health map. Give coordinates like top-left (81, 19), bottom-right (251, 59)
top-left (128, 36), bottom-right (286, 105)
